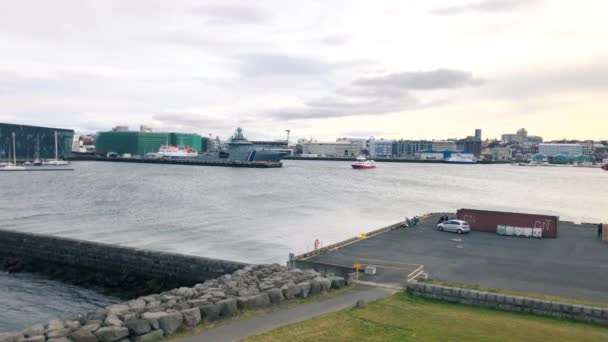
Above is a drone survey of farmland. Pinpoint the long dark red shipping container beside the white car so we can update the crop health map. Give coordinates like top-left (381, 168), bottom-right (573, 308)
top-left (456, 209), bottom-right (559, 238)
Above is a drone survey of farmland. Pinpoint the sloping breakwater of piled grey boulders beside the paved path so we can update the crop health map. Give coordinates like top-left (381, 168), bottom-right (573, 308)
top-left (0, 264), bottom-right (352, 342)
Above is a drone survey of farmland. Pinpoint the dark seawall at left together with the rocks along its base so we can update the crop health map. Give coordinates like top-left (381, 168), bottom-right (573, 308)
top-left (0, 230), bottom-right (247, 296)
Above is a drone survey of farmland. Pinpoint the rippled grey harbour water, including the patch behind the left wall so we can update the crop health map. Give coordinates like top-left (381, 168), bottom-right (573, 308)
top-left (0, 161), bottom-right (608, 331)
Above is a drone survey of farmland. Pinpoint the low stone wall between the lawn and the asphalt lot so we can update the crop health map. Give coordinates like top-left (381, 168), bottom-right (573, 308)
top-left (407, 282), bottom-right (608, 325)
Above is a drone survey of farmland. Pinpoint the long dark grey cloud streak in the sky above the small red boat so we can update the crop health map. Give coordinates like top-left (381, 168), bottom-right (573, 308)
top-left (269, 69), bottom-right (483, 119)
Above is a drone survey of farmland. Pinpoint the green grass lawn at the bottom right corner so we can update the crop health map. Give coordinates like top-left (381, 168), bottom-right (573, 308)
top-left (246, 292), bottom-right (608, 342)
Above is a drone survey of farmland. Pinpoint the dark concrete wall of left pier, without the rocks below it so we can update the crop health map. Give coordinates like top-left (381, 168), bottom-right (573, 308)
top-left (0, 230), bottom-right (247, 283)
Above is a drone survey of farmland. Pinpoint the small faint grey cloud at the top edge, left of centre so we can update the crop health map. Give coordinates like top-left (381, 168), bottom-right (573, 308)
top-left (193, 4), bottom-right (272, 24)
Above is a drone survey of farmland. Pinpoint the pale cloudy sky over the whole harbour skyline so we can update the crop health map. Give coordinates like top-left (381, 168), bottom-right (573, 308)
top-left (0, 0), bottom-right (608, 141)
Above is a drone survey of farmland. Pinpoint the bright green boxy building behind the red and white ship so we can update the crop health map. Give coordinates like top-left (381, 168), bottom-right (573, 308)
top-left (95, 131), bottom-right (208, 156)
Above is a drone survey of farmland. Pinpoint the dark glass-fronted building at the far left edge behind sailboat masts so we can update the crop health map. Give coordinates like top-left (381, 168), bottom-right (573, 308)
top-left (0, 123), bottom-right (74, 161)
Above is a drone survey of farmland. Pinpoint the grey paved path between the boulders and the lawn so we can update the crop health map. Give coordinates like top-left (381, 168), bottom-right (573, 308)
top-left (180, 285), bottom-right (397, 342)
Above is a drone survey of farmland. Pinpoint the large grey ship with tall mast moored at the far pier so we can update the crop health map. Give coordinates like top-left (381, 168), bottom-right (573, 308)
top-left (194, 127), bottom-right (287, 162)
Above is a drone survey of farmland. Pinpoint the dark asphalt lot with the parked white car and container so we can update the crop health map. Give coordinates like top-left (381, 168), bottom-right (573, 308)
top-left (308, 216), bottom-right (608, 302)
